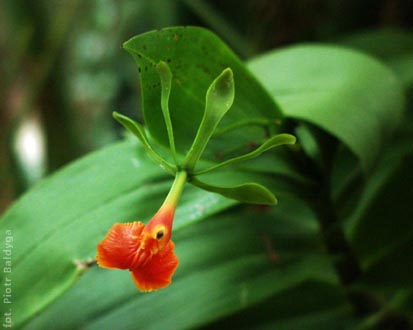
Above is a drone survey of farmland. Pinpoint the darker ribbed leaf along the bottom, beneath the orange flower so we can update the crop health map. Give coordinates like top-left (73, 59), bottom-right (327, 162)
top-left (22, 192), bottom-right (337, 329)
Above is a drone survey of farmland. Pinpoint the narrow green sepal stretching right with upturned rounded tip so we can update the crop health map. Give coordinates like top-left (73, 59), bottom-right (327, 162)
top-left (193, 133), bottom-right (297, 175)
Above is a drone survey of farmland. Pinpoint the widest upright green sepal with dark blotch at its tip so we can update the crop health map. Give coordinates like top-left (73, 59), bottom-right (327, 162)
top-left (183, 68), bottom-right (235, 172)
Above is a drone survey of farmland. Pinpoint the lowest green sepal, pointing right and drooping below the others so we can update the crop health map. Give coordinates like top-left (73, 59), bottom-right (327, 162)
top-left (189, 178), bottom-right (278, 205)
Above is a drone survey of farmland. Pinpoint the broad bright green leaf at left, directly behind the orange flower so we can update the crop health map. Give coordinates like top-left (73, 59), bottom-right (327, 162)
top-left (0, 141), bottom-right (234, 326)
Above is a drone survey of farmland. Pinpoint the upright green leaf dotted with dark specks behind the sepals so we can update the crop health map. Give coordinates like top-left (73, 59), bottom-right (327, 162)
top-left (124, 27), bottom-right (282, 159)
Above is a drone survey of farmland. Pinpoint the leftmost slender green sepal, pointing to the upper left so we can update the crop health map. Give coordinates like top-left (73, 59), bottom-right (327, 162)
top-left (112, 111), bottom-right (176, 175)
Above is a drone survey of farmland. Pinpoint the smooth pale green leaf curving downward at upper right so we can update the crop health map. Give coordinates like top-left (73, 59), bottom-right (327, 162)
top-left (249, 45), bottom-right (404, 169)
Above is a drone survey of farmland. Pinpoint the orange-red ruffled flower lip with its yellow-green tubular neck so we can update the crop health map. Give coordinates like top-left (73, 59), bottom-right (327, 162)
top-left (96, 172), bottom-right (186, 292)
